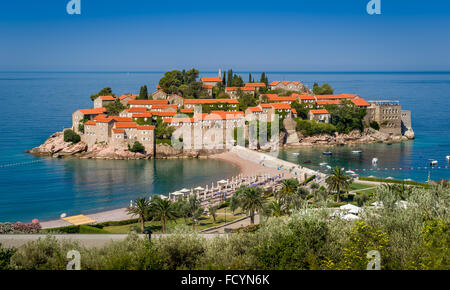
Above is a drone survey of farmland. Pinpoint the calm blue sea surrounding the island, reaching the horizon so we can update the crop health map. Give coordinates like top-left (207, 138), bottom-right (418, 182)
top-left (0, 73), bottom-right (450, 222)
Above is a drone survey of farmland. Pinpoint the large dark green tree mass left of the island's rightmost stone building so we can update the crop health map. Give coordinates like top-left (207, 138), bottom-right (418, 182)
top-left (325, 100), bottom-right (366, 134)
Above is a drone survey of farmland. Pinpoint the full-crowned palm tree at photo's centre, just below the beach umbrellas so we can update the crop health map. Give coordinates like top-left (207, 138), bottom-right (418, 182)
top-left (238, 186), bottom-right (265, 225)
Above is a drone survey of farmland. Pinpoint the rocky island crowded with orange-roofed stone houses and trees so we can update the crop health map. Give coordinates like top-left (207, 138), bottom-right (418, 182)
top-left (28, 69), bottom-right (414, 159)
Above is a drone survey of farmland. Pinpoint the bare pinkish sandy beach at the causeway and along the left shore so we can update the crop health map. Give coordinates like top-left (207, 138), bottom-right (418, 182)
top-left (41, 152), bottom-right (294, 229)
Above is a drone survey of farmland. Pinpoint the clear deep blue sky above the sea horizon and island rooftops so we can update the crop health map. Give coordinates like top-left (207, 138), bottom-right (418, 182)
top-left (0, 0), bottom-right (450, 71)
